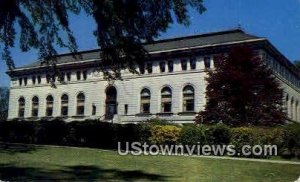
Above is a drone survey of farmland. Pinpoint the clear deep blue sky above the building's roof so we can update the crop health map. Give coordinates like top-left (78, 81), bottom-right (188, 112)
top-left (0, 0), bottom-right (300, 87)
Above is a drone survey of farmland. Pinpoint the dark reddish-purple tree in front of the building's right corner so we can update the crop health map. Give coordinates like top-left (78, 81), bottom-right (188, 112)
top-left (196, 46), bottom-right (285, 126)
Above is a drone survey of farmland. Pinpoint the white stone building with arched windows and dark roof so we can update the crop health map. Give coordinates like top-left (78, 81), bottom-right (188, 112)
top-left (8, 29), bottom-right (300, 123)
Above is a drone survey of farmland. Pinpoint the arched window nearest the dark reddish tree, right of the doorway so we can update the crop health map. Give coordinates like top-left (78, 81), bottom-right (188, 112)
top-left (183, 85), bottom-right (195, 112)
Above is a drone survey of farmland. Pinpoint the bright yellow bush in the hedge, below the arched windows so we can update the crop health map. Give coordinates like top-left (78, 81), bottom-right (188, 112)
top-left (149, 125), bottom-right (181, 145)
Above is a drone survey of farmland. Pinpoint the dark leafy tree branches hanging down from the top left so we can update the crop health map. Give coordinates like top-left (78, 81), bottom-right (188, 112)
top-left (0, 0), bottom-right (205, 78)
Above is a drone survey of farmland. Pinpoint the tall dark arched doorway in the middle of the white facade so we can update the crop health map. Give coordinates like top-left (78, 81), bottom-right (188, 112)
top-left (105, 86), bottom-right (118, 119)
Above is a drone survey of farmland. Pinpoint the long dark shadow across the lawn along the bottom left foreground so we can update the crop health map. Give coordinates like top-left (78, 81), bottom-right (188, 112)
top-left (0, 164), bottom-right (167, 181)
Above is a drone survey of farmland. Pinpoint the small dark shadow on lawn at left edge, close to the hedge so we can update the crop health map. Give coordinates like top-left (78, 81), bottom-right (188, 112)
top-left (0, 143), bottom-right (42, 154)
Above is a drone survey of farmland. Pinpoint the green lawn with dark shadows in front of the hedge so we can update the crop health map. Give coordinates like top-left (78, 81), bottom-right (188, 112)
top-left (0, 145), bottom-right (300, 182)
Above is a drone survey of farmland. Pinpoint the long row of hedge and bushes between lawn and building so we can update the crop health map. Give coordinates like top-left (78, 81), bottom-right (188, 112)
top-left (0, 120), bottom-right (300, 158)
